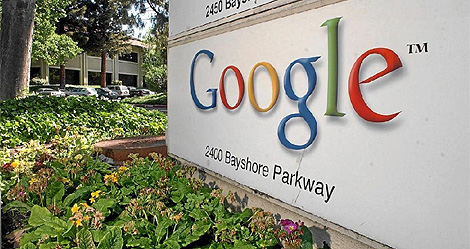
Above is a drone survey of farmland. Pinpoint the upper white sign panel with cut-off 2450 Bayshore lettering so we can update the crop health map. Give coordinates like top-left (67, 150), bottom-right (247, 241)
top-left (170, 0), bottom-right (275, 36)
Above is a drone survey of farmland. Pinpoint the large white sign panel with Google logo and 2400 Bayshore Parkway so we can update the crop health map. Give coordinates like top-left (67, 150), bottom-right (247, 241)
top-left (167, 0), bottom-right (470, 248)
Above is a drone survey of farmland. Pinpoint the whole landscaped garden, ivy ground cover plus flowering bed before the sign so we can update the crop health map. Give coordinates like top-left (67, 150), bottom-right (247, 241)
top-left (0, 96), bottom-right (320, 249)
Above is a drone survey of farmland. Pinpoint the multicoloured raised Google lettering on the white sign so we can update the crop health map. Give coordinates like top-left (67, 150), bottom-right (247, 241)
top-left (189, 17), bottom-right (402, 150)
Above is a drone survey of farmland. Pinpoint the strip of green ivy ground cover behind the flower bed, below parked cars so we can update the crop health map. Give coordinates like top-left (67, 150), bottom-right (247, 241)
top-left (0, 96), bottom-right (166, 147)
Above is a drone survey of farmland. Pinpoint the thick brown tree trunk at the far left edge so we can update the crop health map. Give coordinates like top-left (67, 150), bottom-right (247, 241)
top-left (0, 0), bottom-right (36, 100)
